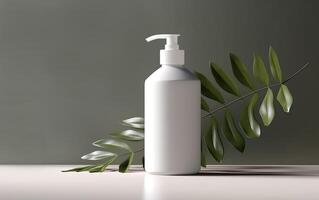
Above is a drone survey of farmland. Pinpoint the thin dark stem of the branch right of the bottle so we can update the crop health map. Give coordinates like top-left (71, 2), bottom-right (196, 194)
top-left (202, 63), bottom-right (309, 118)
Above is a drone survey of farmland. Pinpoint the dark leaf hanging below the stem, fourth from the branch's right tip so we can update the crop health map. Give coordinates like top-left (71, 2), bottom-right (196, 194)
top-left (223, 110), bottom-right (245, 152)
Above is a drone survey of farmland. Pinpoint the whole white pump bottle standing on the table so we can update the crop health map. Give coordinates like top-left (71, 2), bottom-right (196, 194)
top-left (145, 34), bottom-right (201, 175)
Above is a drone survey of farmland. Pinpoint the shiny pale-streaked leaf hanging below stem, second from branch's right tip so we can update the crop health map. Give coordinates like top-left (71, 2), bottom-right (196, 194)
top-left (259, 88), bottom-right (275, 126)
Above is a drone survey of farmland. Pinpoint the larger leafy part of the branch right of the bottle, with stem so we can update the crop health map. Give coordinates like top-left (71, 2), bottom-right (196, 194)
top-left (200, 47), bottom-right (309, 166)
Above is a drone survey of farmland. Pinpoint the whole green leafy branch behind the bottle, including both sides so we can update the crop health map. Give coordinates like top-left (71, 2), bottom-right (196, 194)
top-left (66, 47), bottom-right (309, 172)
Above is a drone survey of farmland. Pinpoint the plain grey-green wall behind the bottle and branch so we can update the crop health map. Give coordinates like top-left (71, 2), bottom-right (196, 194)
top-left (0, 0), bottom-right (319, 164)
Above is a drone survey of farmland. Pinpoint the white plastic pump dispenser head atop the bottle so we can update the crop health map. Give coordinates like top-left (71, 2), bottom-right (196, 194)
top-left (146, 34), bottom-right (184, 66)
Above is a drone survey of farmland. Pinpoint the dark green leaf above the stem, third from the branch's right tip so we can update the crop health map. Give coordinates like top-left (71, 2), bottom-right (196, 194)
top-left (229, 53), bottom-right (254, 90)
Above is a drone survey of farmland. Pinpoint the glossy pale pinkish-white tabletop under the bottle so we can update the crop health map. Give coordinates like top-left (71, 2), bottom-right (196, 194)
top-left (0, 165), bottom-right (319, 200)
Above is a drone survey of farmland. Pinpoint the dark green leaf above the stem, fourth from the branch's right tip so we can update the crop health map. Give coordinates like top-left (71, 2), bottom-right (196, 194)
top-left (210, 63), bottom-right (240, 96)
